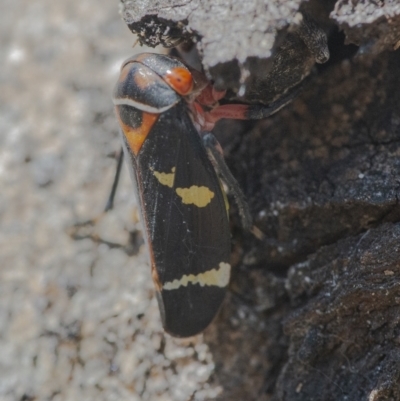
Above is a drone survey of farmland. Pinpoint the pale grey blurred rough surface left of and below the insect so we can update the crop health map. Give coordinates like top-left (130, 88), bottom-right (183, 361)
top-left (0, 0), bottom-right (220, 401)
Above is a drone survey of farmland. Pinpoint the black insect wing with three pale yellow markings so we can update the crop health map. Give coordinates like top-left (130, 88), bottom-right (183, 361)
top-left (123, 102), bottom-right (230, 337)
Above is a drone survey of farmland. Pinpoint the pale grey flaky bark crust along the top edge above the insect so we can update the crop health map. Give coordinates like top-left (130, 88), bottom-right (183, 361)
top-left (120, 0), bottom-right (400, 61)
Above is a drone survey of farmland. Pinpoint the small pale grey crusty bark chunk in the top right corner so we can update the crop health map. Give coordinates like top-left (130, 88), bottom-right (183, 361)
top-left (331, 0), bottom-right (400, 55)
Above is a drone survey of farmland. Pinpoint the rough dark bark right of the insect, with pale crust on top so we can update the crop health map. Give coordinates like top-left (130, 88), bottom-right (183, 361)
top-left (119, 0), bottom-right (400, 401)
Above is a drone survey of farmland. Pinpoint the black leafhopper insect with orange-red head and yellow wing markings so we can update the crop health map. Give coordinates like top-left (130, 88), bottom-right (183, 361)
top-left (113, 53), bottom-right (306, 337)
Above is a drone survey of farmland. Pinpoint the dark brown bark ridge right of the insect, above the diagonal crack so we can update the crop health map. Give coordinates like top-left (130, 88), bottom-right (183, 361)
top-left (235, 53), bottom-right (400, 266)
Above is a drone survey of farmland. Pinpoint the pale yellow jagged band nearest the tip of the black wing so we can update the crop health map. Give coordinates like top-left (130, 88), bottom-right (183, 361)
top-left (163, 262), bottom-right (231, 290)
